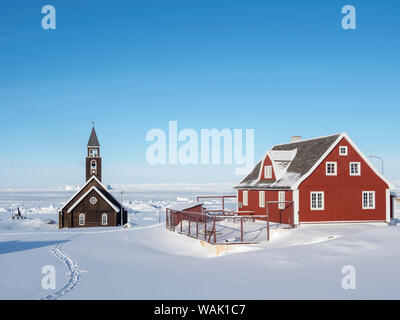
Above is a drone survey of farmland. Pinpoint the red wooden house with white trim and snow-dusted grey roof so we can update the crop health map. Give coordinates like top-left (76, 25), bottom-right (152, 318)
top-left (235, 133), bottom-right (395, 225)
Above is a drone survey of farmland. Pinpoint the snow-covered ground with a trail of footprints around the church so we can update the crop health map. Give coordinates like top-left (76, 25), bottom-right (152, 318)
top-left (0, 185), bottom-right (400, 299)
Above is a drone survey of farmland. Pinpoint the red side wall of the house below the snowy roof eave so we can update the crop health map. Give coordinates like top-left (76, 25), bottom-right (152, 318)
top-left (238, 190), bottom-right (293, 224)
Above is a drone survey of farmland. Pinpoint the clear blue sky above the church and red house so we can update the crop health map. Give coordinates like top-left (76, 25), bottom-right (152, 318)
top-left (0, 0), bottom-right (400, 188)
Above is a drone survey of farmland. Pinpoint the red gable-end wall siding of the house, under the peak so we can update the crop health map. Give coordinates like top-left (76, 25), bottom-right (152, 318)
top-left (299, 138), bottom-right (388, 222)
